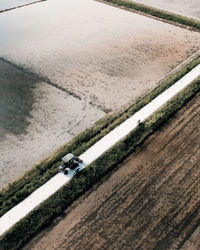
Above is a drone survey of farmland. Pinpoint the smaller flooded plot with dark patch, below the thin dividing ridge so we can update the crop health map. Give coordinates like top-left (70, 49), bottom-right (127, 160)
top-left (0, 60), bottom-right (105, 188)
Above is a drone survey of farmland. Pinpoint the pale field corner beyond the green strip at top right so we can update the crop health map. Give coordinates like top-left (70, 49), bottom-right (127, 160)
top-left (131, 0), bottom-right (200, 20)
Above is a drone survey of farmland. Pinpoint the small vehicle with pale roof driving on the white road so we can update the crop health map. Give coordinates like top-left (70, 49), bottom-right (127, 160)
top-left (58, 153), bottom-right (83, 175)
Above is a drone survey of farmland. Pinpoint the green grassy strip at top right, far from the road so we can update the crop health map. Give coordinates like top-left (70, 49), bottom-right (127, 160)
top-left (100, 0), bottom-right (200, 30)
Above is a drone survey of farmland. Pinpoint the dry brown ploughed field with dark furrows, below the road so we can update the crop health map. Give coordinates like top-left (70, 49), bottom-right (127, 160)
top-left (24, 94), bottom-right (200, 250)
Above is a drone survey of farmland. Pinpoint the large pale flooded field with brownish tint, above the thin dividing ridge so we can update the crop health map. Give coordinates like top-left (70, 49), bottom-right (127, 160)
top-left (0, 0), bottom-right (200, 111)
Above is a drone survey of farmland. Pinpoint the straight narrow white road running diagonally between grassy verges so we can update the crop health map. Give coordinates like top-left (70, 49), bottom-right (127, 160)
top-left (0, 64), bottom-right (200, 235)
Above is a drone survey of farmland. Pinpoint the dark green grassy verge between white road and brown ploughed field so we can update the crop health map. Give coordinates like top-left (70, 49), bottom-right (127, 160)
top-left (0, 75), bottom-right (200, 249)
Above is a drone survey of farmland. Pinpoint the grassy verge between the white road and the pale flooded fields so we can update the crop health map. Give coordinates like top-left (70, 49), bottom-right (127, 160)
top-left (0, 58), bottom-right (200, 216)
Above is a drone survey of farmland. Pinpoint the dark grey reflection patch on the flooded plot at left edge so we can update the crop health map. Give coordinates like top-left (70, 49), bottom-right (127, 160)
top-left (0, 60), bottom-right (38, 139)
